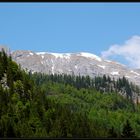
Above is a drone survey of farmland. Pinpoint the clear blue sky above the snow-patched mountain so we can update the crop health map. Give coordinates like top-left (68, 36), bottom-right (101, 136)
top-left (0, 3), bottom-right (140, 67)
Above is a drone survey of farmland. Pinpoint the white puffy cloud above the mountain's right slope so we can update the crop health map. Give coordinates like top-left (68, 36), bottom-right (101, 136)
top-left (101, 36), bottom-right (140, 68)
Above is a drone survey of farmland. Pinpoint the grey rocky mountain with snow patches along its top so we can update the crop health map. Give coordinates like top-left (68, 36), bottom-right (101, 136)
top-left (11, 50), bottom-right (140, 85)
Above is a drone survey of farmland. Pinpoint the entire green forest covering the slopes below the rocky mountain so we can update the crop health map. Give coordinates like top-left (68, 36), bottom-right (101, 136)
top-left (0, 51), bottom-right (140, 138)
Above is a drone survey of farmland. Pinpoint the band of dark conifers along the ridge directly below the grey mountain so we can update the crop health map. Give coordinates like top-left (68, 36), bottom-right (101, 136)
top-left (30, 73), bottom-right (140, 102)
